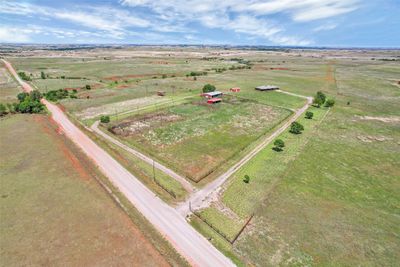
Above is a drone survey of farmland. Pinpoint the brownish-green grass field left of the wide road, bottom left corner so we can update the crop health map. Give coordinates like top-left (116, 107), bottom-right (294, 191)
top-left (0, 114), bottom-right (186, 266)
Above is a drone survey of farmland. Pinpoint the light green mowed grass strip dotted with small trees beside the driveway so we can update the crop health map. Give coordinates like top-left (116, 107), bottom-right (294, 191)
top-left (222, 107), bottom-right (327, 219)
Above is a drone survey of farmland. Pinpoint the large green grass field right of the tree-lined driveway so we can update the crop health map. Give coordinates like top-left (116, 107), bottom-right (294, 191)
top-left (193, 55), bottom-right (400, 266)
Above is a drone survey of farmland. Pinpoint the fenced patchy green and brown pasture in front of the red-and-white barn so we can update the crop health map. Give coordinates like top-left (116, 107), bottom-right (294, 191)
top-left (105, 96), bottom-right (290, 182)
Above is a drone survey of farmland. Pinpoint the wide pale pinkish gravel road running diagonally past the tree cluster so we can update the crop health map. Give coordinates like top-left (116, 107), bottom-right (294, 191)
top-left (3, 60), bottom-right (234, 267)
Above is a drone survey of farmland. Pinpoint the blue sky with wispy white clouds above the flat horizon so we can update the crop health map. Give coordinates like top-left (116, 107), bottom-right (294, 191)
top-left (0, 0), bottom-right (400, 47)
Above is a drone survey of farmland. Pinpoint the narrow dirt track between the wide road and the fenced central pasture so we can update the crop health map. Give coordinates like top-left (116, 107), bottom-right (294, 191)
top-left (90, 121), bottom-right (194, 193)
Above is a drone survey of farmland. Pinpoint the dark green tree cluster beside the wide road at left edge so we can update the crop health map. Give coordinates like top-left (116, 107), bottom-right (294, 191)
top-left (0, 90), bottom-right (45, 116)
